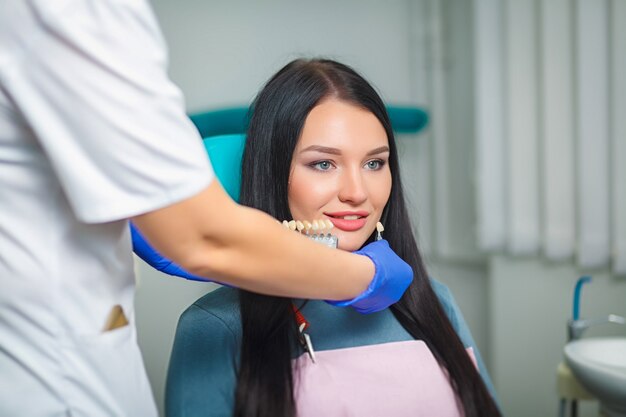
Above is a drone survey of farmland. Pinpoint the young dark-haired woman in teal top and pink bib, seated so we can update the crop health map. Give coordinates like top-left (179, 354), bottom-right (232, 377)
top-left (166, 60), bottom-right (499, 417)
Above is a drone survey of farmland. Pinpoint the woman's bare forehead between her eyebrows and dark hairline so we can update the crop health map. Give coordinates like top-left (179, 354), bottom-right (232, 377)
top-left (296, 98), bottom-right (389, 150)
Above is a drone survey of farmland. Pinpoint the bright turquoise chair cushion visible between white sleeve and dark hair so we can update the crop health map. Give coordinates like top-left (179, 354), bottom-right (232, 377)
top-left (203, 134), bottom-right (246, 201)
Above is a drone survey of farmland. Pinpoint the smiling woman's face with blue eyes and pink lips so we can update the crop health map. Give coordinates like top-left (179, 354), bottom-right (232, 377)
top-left (288, 98), bottom-right (391, 251)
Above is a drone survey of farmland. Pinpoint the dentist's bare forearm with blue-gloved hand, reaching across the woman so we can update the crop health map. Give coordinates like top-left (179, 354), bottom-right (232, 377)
top-left (132, 181), bottom-right (413, 311)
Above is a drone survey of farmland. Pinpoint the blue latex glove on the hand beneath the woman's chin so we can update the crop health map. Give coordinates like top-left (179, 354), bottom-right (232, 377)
top-left (327, 240), bottom-right (413, 314)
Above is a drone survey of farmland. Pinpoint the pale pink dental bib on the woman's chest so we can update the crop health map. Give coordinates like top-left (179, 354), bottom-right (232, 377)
top-left (293, 340), bottom-right (476, 417)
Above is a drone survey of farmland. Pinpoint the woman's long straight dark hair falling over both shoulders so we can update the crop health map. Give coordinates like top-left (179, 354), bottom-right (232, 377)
top-left (234, 59), bottom-right (499, 417)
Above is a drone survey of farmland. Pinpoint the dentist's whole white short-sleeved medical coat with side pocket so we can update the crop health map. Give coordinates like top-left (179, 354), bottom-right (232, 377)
top-left (0, 0), bottom-right (213, 417)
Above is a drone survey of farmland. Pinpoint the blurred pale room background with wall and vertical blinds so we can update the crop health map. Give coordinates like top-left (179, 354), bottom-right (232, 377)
top-left (136, 0), bottom-right (626, 417)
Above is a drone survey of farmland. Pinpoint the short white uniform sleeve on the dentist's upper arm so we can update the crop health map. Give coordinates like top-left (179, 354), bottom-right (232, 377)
top-left (2, 0), bottom-right (214, 223)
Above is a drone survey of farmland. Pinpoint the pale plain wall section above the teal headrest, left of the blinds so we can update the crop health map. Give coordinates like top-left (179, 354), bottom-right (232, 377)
top-left (152, 0), bottom-right (411, 110)
